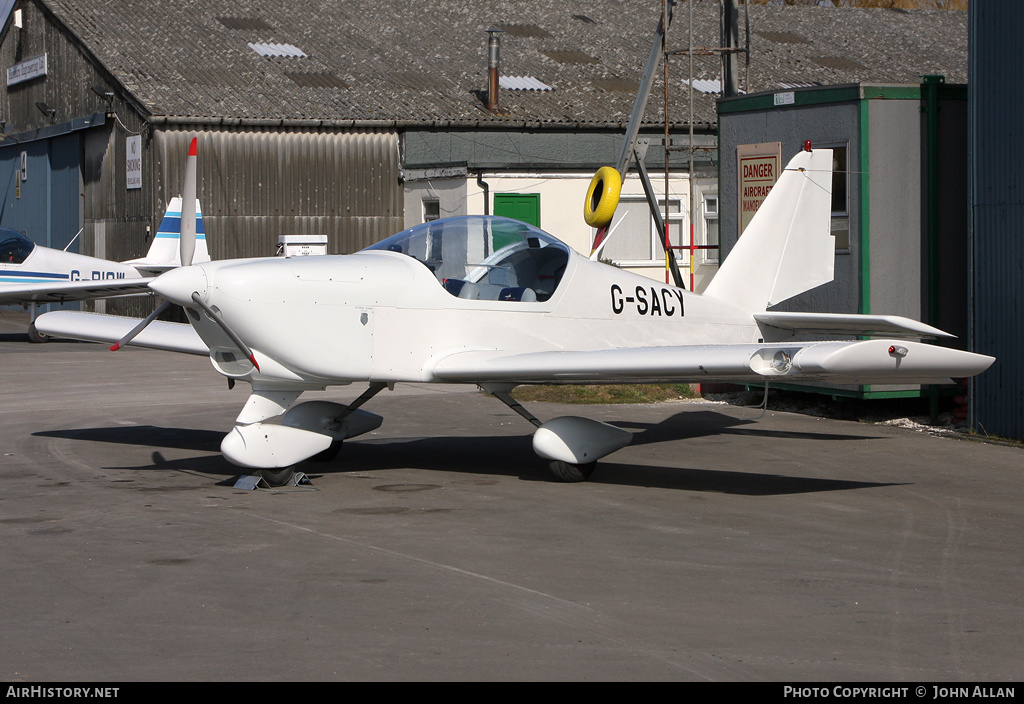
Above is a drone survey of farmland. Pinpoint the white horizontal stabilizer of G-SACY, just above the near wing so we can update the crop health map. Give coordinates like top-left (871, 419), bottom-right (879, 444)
top-left (754, 312), bottom-right (956, 339)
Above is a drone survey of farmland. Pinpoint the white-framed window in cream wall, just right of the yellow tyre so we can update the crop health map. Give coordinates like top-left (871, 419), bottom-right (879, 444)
top-left (601, 197), bottom-right (690, 266)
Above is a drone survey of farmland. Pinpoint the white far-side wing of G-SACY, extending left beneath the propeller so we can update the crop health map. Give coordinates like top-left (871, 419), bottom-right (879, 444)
top-left (36, 310), bottom-right (210, 356)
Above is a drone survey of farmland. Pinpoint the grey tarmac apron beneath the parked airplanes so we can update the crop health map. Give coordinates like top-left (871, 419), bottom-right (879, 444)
top-left (0, 311), bottom-right (1024, 683)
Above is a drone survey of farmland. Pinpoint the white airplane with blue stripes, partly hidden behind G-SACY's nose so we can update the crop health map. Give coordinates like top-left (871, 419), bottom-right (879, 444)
top-left (0, 141), bottom-right (210, 342)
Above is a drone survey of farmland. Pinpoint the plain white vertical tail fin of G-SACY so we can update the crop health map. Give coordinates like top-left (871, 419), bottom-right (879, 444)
top-left (705, 149), bottom-right (836, 311)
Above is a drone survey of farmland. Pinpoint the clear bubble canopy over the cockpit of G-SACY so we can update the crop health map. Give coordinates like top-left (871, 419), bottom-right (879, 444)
top-left (367, 215), bottom-right (569, 302)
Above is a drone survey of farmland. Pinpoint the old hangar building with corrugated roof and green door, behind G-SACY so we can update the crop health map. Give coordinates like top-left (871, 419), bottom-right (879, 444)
top-left (0, 0), bottom-right (966, 312)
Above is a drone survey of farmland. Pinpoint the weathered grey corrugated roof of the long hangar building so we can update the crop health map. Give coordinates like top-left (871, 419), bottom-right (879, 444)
top-left (37, 0), bottom-right (967, 125)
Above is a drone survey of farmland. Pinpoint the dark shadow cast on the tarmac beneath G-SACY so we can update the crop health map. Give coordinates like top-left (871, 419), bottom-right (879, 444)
top-left (29, 411), bottom-right (894, 495)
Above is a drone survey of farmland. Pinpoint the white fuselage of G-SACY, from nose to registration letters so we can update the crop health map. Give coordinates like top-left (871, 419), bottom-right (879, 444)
top-left (160, 251), bottom-right (758, 385)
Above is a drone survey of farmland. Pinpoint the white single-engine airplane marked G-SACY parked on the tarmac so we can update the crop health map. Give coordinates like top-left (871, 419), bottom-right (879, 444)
top-left (38, 141), bottom-right (993, 484)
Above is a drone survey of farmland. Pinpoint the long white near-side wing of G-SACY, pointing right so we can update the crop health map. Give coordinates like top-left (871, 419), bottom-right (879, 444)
top-left (434, 340), bottom-right (994, 384)
